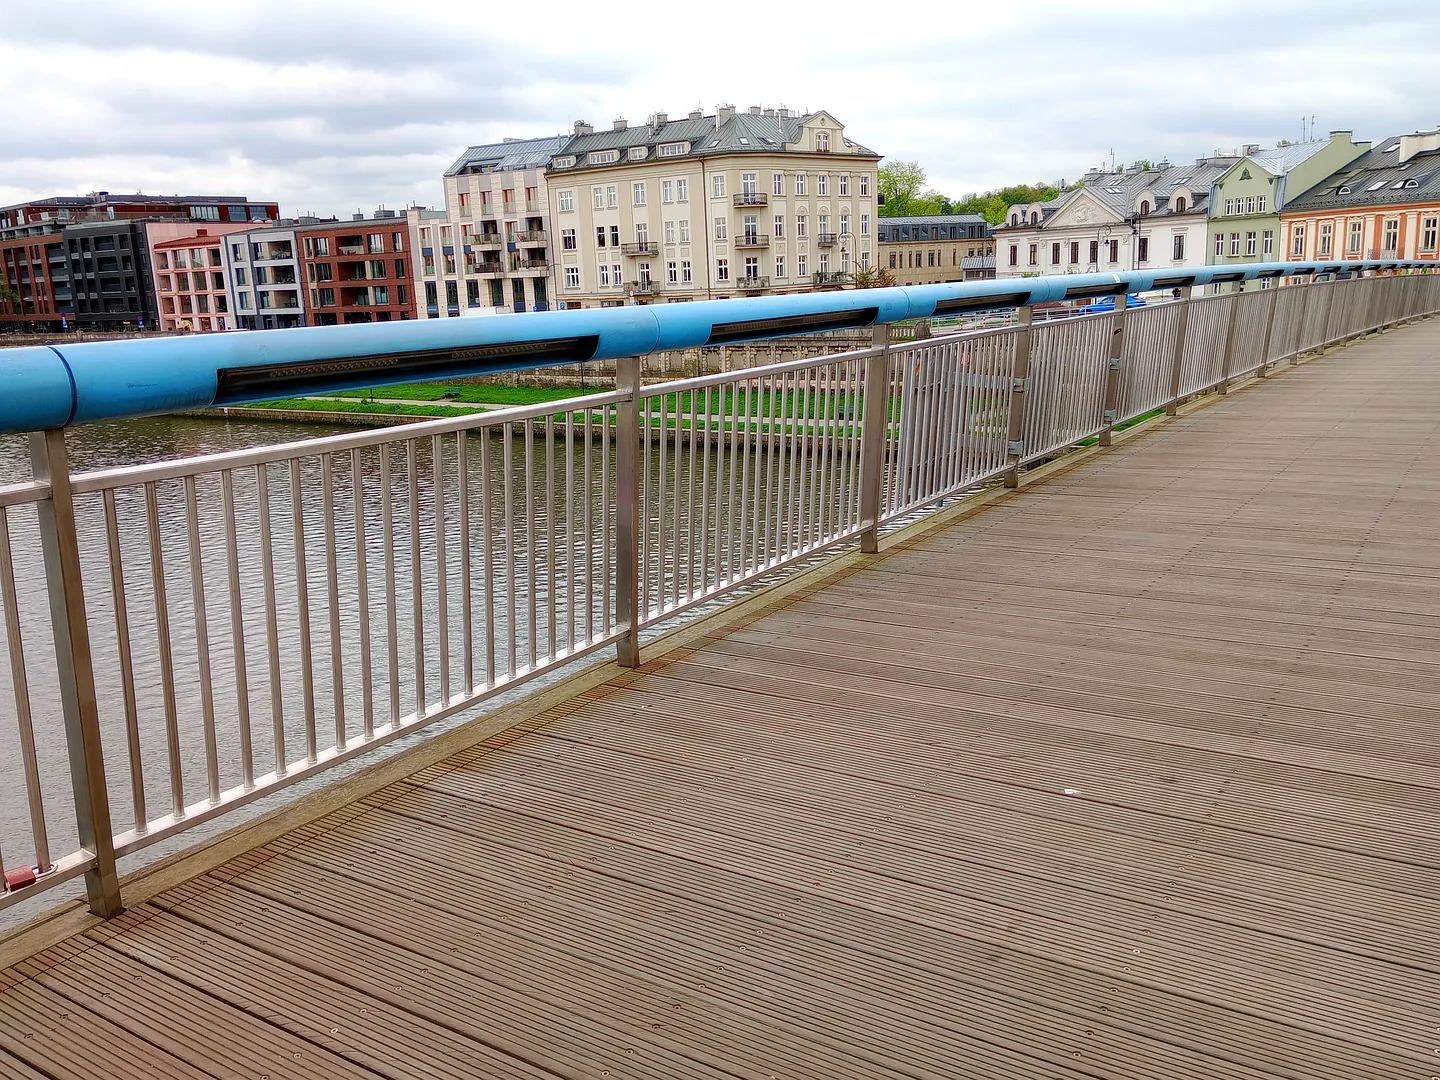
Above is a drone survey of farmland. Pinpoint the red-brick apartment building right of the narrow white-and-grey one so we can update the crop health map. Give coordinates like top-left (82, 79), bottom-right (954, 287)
top-left (295, 210), bottom-right (415, 327)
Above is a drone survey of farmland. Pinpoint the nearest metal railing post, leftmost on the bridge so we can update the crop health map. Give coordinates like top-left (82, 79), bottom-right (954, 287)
top-left (30, 431), bottom-right (124, 919)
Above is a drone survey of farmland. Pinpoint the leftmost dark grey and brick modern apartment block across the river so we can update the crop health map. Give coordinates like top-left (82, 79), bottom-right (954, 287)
top-left (0, 192), bottom-right (279, 330)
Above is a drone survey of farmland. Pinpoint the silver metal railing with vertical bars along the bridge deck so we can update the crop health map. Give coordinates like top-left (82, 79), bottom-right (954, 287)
top-left (0, 266), bottom-right (1440, 916)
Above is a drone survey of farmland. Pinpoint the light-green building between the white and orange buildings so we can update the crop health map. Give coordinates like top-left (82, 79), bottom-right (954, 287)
top-left (1205, 131), bottom-right (1369, 264)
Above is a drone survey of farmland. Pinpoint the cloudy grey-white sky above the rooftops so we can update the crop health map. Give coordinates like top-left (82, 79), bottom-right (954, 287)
top-left (0, 0), bottom-right (1440, 216)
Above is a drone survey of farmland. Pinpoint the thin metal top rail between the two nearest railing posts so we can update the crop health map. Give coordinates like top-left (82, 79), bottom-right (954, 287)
top-left (68, 390), bottom-right (629, 495)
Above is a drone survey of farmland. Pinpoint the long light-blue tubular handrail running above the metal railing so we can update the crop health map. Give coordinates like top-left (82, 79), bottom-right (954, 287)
top-left (0, 262), bottom-right (1416, 432)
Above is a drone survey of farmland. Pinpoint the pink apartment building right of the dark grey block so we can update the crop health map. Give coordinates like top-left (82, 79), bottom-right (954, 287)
top-left (145, 222), bottom-right (249, 333)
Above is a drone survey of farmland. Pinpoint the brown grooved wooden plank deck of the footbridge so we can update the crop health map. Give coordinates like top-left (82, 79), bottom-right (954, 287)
top-left (0, 323), bottom-right (1440, 1080)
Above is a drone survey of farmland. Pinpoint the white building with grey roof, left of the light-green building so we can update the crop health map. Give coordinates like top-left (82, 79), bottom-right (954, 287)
top-left (995, 154), bottom-right (1240, 278)
